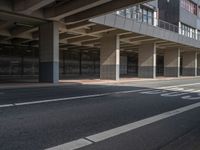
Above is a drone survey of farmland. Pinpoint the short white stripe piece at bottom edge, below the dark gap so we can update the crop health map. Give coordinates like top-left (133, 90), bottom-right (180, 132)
top-left (45, 139), bottom-right (92, 150)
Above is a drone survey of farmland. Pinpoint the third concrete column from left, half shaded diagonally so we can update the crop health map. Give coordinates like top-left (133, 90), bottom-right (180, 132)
top-left (138, 43), bottom-right (156, 78)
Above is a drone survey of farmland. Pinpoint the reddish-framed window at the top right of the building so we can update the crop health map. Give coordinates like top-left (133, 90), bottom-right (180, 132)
top-left (181, 0), bottom-right (197, 15)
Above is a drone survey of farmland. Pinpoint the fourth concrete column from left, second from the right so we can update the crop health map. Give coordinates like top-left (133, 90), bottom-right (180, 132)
top-left (164, 48), bottom-right (180, 77)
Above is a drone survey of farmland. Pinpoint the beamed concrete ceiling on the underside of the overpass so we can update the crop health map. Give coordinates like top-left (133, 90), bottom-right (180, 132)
top-left (0, 0), bottom-right (198, 52)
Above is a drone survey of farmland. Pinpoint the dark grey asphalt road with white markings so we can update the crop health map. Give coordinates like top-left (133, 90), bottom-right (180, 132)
top-left (0, 78), bottom-right (200, 150)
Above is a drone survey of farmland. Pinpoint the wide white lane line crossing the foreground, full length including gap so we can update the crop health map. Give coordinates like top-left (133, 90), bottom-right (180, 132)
top-left (46, 102), bottom-right (200, 150)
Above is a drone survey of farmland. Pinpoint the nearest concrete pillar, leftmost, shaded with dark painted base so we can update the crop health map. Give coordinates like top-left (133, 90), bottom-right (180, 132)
top-left (39, 22), bottom-right (59, 83)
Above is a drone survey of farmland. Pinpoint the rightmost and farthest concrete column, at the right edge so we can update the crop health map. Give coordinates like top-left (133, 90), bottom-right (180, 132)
top-left (182, 51), bottom-right (197, 76)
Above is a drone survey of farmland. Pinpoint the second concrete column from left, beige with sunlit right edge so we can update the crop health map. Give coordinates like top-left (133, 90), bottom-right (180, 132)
top-left (100, 35), bottom-right (120, 80)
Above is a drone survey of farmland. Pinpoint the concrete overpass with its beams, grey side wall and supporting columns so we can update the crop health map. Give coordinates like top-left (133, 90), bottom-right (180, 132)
top-left (0, 0), bottom-right (200, 83)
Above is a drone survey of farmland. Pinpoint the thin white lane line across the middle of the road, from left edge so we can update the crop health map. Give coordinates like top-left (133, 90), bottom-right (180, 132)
top-left (0, 89), bottom-right (148, 108)
